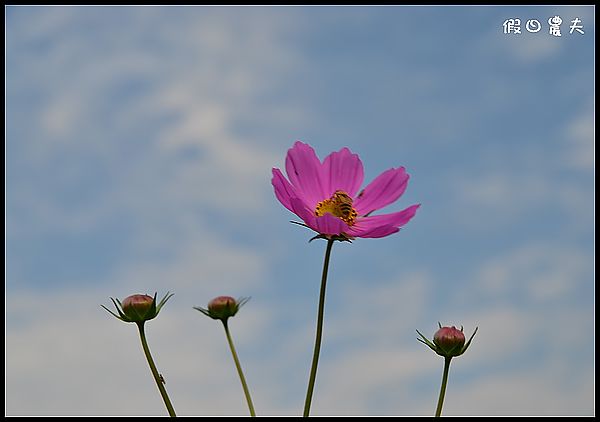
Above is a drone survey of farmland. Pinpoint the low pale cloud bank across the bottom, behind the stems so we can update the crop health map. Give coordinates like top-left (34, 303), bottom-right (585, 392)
top-left (6, 252), bottom-right (593, 415)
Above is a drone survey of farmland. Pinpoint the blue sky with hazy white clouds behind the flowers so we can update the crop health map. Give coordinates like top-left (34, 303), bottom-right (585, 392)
top-left (5, 6), bottom-right (595, 415)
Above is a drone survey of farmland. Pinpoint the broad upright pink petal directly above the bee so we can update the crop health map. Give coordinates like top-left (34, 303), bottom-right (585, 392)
top-left (322, 148), bottom-right (364, 197)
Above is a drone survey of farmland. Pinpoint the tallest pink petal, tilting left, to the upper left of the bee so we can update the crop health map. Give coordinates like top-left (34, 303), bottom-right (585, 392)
top-left (285, 141), bottom-right (329, 208)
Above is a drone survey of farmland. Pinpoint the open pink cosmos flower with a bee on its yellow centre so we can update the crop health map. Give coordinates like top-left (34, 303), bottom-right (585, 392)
top-left (271, 141), bottom-right (420, 239)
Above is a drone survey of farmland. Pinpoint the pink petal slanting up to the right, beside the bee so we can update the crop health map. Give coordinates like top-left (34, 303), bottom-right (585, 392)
top-left (354, 167), bottom-right (409, 215)
